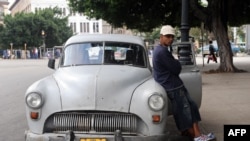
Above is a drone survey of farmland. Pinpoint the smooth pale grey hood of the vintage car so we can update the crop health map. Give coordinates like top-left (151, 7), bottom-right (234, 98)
top-left (54, 65), bottom-right (152, 112)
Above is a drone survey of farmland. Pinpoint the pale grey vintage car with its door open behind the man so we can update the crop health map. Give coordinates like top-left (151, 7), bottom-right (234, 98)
top-left (25, 34), bottom-right (201, 141)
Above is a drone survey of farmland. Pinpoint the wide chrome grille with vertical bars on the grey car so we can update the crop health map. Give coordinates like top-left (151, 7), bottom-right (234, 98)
top-left (44, 112), bottom-right (137, 134)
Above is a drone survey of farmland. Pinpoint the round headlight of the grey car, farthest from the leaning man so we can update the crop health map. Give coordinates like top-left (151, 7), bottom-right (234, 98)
top-left (26, 93), bottom-right (43, 109)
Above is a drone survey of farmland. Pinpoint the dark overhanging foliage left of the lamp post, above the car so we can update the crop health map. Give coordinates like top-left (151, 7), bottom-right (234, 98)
top-left (70, 0), bottom-right (184, 31)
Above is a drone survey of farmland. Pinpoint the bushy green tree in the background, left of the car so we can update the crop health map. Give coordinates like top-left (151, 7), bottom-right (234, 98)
top-left (0, 8), bottom-right (73, 48)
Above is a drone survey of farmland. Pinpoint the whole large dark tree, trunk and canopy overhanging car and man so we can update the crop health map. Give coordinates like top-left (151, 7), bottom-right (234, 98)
top-left (69, 0), bottom-right (250, 72)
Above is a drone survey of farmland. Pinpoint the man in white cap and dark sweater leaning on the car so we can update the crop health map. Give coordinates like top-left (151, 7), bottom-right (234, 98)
top-left (153, 25), bottom-right (215, 141)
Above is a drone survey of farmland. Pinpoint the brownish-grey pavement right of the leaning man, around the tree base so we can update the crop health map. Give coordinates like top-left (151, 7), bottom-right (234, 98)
top-left (168, 54), bottom-right (250, 141)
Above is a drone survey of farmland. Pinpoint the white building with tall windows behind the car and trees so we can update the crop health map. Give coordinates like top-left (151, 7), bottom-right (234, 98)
top-left (9, 0), bottom-right (131, 34)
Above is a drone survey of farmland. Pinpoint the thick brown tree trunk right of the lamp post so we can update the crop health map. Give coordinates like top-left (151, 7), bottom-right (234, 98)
top-left (209, 0), bottom-right (239, 72)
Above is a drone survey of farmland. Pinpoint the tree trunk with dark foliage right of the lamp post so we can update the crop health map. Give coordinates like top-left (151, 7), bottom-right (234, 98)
top-left (191, 0), bottom-right (250, 72)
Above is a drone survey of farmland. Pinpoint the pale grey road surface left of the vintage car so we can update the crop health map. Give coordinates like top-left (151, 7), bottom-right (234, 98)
top-left (0, 60), bottom-right (53, 141)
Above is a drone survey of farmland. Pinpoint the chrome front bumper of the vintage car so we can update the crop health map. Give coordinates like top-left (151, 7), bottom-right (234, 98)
top-left (25, 130), bottom-right (169, 141)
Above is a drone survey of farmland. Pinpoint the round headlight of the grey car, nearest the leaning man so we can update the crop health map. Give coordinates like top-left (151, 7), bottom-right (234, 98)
top-left (148, 94), bottom-right (165, 111)
